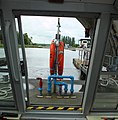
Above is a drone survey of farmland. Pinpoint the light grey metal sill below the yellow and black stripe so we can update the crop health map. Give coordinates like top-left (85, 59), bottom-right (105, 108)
top-left (21, 112), bottom-right (86, 120)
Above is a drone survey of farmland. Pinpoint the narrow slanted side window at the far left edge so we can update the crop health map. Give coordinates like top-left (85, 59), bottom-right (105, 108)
top-left (0, 20), bottom-right (15, 107)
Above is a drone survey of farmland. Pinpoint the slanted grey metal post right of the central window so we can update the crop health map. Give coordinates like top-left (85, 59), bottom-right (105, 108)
top-left (83, 13), bottom-right (111, 115)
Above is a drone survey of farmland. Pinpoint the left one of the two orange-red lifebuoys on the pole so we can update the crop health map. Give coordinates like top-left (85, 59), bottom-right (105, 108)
top-left (50, 41), bottom-right (56, 75)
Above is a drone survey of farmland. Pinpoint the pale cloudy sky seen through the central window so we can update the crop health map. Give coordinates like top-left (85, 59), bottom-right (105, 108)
top-left (16, 16), bottom-right (85, 44)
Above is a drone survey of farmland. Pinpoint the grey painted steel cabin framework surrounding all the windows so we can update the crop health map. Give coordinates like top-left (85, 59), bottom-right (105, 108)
top-left (0, 0), bottom-right (118, 120)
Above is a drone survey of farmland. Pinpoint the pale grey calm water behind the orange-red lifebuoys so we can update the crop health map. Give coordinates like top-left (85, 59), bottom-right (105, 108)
top-left (0, 48), bottom-right (79, 80)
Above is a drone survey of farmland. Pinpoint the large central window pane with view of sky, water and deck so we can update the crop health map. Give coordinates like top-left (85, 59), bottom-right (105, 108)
top-left (20, 16), bottom-right (94, 109)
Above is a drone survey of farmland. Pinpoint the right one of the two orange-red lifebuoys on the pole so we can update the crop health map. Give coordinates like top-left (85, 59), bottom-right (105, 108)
top-left (58, 41), bottom-right (64, 75)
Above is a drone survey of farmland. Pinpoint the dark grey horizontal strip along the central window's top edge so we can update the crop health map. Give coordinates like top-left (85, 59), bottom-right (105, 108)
top-left (13, 10), bottom-right (99, 18)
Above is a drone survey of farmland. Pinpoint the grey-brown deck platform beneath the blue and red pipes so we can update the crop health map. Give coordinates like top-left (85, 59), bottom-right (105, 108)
top-left (29, 79), bottom-right (83, 106)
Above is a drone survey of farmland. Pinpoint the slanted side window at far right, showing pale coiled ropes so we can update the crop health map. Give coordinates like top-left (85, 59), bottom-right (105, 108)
top-left (92, 20), bottom-right (118, 111)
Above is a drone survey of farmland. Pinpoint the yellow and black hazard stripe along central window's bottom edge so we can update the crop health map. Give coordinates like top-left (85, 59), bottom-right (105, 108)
top-left (27, 106), bottom-right (82, 111)
